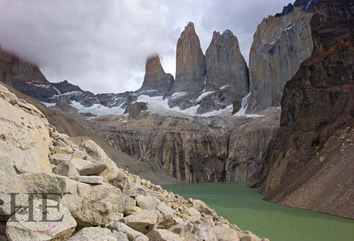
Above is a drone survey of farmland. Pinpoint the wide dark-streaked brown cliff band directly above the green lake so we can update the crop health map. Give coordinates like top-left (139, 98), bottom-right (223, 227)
top-left (92, 111), bottom-right (279, 182)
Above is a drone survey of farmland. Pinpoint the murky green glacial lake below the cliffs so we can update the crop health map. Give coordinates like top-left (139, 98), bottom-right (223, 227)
top-left (164, 182), bottom-right (354, 241)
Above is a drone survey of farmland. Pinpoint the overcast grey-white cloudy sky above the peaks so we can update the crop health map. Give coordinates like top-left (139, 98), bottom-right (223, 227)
top-left (0, 0), bottom-right (291, 93)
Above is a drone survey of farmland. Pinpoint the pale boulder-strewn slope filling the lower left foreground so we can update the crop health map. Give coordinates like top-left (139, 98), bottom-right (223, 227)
top-left (0, 85), bottom-right (266, 241)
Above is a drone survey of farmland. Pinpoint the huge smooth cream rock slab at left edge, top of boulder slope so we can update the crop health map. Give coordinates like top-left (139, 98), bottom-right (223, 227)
top-left (0, 85), bottom-right (51, 172)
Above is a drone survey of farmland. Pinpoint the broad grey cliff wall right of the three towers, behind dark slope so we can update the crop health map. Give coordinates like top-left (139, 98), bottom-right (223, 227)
top-left (248, 0), bottom-right (313, 112)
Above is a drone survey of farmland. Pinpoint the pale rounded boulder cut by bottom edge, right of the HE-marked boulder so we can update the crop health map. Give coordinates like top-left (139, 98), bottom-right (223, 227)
top-left (68, 227), bottom-right (117, 241)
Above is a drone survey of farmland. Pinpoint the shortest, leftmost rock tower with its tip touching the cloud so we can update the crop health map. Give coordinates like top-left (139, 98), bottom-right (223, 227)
top-left (139, 55), bottom-right (174, 95)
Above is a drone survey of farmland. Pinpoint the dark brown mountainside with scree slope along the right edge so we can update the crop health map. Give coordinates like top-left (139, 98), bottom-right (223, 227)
top-left (251, 0), bottom-right (354, 218)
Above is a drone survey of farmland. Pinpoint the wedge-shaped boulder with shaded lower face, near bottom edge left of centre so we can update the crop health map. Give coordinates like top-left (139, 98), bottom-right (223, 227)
top-left (124, 210), bottom-right (159, 234)
